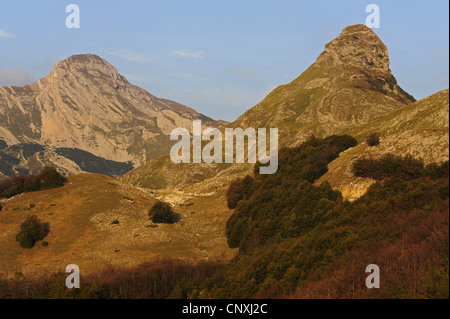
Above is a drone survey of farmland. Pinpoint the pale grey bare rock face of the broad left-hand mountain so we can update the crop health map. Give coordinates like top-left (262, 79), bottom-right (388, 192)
top-left (0, 54), bottom-right (219, 174)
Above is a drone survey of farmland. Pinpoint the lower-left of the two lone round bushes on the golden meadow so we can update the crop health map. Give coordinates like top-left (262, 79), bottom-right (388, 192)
top-left (16, 215), bottom-right (50, 248)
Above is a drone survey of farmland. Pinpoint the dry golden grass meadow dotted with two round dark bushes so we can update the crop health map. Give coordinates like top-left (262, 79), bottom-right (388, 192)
top-left (0, 174), bottom-right (234, 276)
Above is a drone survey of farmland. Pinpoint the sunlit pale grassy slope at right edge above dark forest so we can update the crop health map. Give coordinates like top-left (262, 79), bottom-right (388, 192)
top-left (318, 89), bottom-right (449, 199)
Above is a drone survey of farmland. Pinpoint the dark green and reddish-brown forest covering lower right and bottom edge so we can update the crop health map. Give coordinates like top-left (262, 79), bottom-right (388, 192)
top-left (0, 136), bottom-right (449, 298)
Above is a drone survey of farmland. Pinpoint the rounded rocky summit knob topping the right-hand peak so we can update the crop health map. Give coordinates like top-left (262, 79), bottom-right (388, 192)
top-left (317, 24), bottom-right (390, 73)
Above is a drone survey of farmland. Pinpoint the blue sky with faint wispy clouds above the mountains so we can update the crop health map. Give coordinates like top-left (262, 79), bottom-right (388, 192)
top-left (0, 0), bottom-right (449, 121)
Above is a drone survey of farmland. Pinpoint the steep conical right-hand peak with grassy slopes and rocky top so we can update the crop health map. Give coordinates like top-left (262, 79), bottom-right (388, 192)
top-left (233, 25), bottom-right (415, 146)
